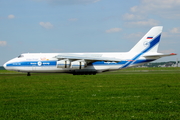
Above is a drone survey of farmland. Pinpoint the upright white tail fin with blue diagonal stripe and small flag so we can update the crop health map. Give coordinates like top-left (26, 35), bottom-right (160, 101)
top-left (129, 26), bottom-right (163, 53)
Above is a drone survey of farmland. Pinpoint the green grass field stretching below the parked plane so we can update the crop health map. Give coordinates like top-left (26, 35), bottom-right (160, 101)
top-left (0, 68), bottom-right (180, 120)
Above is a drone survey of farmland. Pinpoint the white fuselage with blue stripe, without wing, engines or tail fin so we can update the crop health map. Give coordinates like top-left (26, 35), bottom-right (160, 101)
top-left (4, 52), bottom-right (155, 73)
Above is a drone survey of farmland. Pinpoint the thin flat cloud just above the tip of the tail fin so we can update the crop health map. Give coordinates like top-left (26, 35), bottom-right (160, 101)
top-left (126, 19), bottom-right (159, 26)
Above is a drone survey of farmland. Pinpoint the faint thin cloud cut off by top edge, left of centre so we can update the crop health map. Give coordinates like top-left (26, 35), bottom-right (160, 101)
top-left (35, 0), bottom-right (100, 5)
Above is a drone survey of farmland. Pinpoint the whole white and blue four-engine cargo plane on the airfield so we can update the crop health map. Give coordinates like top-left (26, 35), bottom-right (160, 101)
top-left (3, 26), bottom-right (176, 76)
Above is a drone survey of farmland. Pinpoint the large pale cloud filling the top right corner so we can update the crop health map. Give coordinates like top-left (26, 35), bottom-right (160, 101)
top-left (130, 0), bottom-right (180, 19)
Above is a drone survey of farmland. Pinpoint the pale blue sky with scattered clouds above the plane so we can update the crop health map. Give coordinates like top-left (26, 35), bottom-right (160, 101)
top-left (0, 0), bottom-right (180, 65)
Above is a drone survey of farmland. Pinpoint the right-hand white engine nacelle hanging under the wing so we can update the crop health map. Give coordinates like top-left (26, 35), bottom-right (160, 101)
top-left (71, 61), bottom-right (86, 69)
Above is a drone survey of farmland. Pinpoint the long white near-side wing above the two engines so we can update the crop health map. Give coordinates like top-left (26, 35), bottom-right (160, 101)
top-left (55, 54), bottom-right (121, 62)
